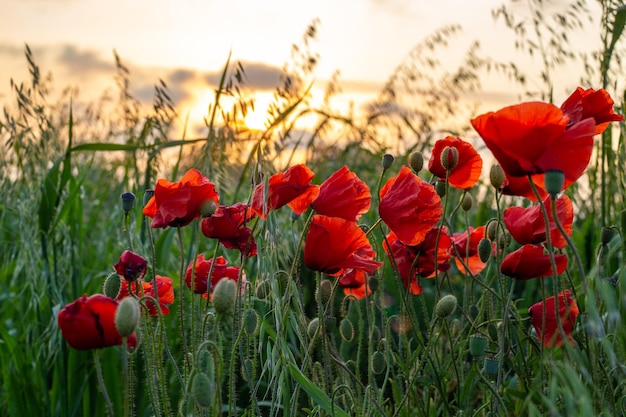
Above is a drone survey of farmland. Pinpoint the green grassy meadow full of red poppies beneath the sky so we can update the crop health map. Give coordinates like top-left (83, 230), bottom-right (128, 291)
top-left (0, 1), bottom-right (626, 417)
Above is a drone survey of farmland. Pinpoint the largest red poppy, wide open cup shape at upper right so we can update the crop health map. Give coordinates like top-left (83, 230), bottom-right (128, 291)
top-left (472, 102), bottom-right (595, 183)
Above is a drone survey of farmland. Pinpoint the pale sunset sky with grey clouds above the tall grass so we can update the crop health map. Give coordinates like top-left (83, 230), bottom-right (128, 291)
top-left (0, 0), bottom-right (604, 133)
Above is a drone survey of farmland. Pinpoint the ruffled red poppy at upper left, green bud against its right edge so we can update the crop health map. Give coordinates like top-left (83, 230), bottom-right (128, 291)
top-left (143, 168), bottom-right (219, 228)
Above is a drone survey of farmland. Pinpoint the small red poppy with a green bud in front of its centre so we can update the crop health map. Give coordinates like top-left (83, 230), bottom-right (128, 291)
top-left (428, 136), bottom-right (483, 190)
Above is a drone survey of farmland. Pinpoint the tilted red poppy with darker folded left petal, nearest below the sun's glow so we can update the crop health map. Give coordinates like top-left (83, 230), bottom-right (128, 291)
top-left (251, 164), bottom-right (319, 219)
